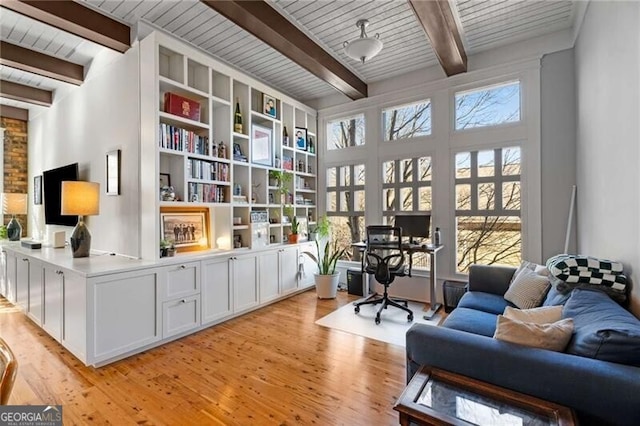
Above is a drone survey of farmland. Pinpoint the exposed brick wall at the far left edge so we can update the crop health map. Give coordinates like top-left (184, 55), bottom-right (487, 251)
top-left (0, 117), bottom-right (31, 237)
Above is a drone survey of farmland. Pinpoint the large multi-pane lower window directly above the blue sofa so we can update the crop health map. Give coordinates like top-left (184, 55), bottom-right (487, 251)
top-left (455, 147), bottom-right (522, 273)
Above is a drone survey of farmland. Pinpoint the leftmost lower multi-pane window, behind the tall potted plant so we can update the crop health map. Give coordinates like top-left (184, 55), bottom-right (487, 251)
top-left (327, 164), bottom-right (366, 257)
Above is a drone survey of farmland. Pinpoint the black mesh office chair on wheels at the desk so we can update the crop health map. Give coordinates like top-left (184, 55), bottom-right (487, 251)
top-left (354, 225), bottom-right (413, 324)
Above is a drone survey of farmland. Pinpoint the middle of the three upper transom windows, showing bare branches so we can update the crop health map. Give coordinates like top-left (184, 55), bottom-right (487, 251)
top-left (382, 100), bottom-right (431, 141)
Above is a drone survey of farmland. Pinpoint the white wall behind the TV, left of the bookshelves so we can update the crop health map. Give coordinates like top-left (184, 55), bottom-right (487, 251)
top-left (29, 46), bottom-right (140, 257)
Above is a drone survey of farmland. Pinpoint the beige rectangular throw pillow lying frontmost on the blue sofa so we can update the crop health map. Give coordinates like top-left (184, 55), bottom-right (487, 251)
top-left (493, 315), bottom-right (573, 352)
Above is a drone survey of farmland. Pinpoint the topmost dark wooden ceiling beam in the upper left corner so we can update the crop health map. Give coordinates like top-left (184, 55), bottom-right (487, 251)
top-left (0, 0), bottom-right (131, 53)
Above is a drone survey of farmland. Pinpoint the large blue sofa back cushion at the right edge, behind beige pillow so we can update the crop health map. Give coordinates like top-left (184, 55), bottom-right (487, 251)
top-left (563, 289), bottom-right (640, 366)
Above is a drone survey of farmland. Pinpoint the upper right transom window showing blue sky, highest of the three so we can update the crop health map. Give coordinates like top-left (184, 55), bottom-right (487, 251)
top-left (455, 81), bottom-right (520, 130)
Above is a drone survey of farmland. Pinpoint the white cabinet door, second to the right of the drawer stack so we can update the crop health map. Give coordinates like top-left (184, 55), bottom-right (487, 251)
top-left (231, 254), bottom-right (258, 312)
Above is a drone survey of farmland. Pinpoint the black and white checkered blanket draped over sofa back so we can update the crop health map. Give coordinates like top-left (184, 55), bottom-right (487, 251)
top-left (547, 254), bottom-right (627, 293)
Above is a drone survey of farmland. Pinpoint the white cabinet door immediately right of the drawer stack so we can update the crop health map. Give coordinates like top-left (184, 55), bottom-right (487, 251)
top-left (201, 257), bottom-right (233, 325)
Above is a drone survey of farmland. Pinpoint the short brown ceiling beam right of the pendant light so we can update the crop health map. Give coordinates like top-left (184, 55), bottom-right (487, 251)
top-left (408, 0), bottom-right (467, 77)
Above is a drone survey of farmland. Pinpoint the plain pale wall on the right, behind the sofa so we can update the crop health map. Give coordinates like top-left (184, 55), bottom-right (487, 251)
top-left (575, 2), bottom-right (640, 316)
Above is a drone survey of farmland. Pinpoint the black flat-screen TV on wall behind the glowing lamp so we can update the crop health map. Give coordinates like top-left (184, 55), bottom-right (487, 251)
top-left (42, 163), bottom-right (78, 226)
